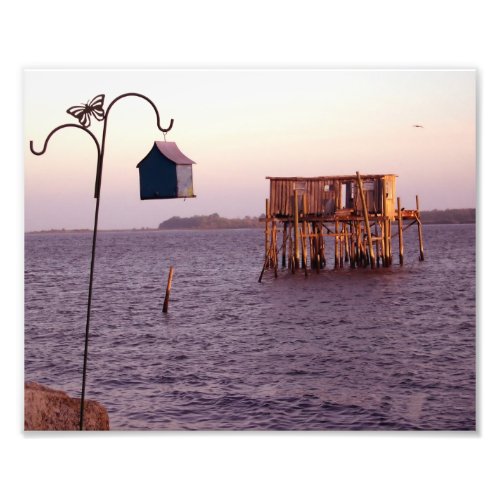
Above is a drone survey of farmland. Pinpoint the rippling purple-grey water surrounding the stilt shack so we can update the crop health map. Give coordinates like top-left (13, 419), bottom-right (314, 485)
top-left (25, 225), bottom-right (476, 430)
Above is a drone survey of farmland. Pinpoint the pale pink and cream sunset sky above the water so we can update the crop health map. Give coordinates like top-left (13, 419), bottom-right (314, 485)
top-left (24, 70), bottom-right (476, 231)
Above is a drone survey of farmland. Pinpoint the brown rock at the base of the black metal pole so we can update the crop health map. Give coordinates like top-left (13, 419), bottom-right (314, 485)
top-left (24, 382), bottom-right (109, 431)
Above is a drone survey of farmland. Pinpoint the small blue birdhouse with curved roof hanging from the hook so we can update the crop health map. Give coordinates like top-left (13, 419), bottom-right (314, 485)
top-left (137, 141), bottom-right (196, 200)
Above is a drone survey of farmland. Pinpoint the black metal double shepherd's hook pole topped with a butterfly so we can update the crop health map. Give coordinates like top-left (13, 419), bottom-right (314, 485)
top-left (30, 92), bottom-right (174, 430)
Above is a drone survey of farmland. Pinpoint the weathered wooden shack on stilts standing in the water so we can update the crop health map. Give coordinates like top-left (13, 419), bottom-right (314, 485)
top-left (259, 172), bottom-right (424, 281)
